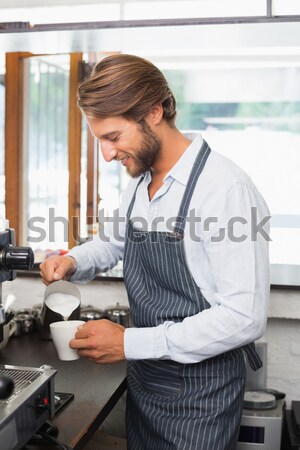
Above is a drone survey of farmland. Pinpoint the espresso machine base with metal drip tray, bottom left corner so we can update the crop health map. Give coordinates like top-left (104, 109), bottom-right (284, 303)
top-left (0, 365), bottom-right (56, 450)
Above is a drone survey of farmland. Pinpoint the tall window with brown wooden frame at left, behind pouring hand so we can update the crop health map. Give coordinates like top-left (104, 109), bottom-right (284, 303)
top-left (5, 52), bottom-right (86, 250)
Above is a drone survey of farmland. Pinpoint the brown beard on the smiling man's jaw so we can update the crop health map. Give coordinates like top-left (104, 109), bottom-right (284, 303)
top-left (127, 121), bottom-right (161, 178)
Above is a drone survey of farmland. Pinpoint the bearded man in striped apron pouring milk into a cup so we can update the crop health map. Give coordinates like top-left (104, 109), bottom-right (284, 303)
top-left (41, 55), bottom-right (269, 450)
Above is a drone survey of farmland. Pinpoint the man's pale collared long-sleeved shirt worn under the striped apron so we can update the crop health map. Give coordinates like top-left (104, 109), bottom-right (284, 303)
top-left (69, 135), bottom-right (269, 363)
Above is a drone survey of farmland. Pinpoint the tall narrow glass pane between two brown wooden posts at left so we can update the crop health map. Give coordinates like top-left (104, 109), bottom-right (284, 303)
top-left (24, 55), bottom-right (69, 250)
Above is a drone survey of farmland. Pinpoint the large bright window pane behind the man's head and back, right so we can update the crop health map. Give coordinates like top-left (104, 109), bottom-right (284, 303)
top-left (153, 55), bottom-right (300, 274)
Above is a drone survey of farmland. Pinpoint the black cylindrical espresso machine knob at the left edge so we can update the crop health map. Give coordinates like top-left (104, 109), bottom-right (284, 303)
top-left (0, 246), bottom-right (34, 271)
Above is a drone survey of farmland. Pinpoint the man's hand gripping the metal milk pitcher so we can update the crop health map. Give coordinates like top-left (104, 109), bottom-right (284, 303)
top-left (40, 255), bottom-right (77, 286)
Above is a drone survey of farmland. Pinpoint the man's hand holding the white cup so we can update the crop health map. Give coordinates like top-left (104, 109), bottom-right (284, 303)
top-left (69, 319), bottom-right (125, 364)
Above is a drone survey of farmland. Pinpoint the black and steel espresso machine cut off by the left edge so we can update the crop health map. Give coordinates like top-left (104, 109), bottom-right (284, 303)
top-left (0, 223), bottom-right (56, 450)
